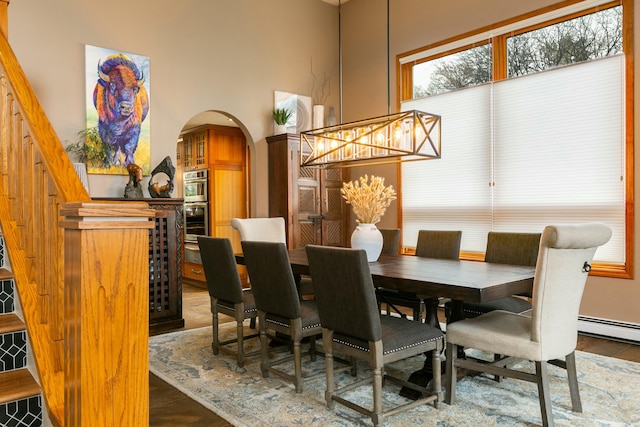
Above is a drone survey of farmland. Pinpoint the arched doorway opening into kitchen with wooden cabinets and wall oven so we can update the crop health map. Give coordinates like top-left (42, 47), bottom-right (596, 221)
top-left (176, 110), bottom-right (250, 287)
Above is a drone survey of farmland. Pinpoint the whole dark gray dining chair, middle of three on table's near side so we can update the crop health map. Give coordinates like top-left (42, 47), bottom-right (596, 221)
top-left (242, 240), bottom-right (322, 393)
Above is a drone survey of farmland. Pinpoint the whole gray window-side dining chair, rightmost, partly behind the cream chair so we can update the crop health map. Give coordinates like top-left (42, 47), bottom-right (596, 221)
top-left (445, 231), bottom-right (541, 319)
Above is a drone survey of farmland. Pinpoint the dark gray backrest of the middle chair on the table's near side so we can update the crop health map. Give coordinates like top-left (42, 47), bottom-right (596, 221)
top-left (242, 240), bottom-right (300, 319)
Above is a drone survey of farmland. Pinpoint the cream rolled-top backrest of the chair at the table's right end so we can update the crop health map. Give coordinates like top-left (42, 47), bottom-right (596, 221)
top-left (531, 223), bottom-right (611, 360)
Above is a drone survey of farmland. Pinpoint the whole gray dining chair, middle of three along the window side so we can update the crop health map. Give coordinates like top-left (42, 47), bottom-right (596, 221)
top-left (377, 230), bottom-right (462, 321)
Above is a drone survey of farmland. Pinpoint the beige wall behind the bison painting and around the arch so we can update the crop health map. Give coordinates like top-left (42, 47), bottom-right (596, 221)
top-left (9, 0), bottom-right (339, 216)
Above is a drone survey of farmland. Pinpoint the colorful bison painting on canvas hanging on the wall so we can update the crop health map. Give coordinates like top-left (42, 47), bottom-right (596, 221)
top-left (85, 45), bottom-right (151, 175)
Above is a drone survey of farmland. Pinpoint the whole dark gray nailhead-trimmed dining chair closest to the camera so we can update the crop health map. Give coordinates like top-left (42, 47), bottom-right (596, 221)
top-left (306, 245), bottom-right (444, 426)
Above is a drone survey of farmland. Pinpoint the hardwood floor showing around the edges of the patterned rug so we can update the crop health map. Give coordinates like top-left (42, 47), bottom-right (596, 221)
top-left (149, 284), bottom-right (640, 427)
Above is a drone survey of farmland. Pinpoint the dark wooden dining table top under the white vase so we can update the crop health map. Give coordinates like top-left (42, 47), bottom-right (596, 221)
top-left (236, 248), bottom-right (535, 303)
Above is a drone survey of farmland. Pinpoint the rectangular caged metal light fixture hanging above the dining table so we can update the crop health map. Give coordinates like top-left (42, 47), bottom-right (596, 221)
top-left (300, 110), bottom-right (441, 168)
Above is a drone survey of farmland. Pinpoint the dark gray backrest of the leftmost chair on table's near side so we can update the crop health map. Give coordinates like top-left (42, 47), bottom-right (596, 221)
top-left (198, 236), bottom-right (242, 304)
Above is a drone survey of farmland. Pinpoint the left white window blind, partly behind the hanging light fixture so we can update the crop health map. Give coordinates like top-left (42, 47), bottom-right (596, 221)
top-left (401, 84), bottom-right (491, 251)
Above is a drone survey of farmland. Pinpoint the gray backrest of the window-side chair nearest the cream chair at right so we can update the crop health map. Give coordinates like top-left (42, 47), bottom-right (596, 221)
top-left (484, 231), bottom-right (541, 267)
